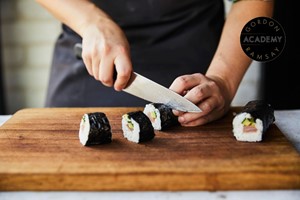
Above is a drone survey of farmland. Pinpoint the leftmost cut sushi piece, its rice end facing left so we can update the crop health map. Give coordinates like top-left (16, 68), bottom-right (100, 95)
top-left (79, 112), bottom-right (112, 146)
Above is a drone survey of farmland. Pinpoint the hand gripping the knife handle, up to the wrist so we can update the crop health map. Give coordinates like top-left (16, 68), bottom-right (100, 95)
top-left (82, 18), bottom-right (132, 91)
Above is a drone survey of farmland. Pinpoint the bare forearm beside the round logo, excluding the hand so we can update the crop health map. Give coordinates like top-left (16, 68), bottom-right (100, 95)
top-left (206, 0), bottom-right (273, 100)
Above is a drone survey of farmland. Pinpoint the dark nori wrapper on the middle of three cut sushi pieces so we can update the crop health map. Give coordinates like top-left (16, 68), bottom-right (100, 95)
top-left (127, 111), bottom-right (155, 142)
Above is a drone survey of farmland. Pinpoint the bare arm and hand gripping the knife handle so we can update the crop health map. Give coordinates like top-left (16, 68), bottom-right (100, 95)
top-left (36, 0), bottom-right (132, 91)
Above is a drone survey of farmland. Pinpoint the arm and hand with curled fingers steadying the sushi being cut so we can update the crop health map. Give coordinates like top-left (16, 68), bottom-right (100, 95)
top-left (170, 0), bottom-right (273, 126)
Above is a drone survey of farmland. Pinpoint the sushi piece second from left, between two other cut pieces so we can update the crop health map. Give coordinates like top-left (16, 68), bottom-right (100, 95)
top-left (122, 111), bottom-right (155, 143)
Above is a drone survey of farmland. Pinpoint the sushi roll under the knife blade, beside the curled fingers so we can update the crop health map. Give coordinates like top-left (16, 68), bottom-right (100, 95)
top-left (143, 103), bottom-right (179, 130)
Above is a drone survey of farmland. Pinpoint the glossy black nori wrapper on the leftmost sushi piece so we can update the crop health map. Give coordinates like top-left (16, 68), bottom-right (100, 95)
top-left (86, 112), bottom-right (112, 146)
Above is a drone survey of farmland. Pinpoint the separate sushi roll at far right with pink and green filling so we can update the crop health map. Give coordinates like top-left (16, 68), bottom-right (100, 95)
top-left (232, 100), bottom-right (275, 142)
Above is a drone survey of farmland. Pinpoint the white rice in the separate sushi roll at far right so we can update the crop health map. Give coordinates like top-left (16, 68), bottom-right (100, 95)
top-left (232, 113), bottom-right (263, 142)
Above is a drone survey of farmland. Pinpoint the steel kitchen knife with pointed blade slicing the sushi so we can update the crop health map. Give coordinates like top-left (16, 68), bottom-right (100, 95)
top-left (74, 43), bottom-right (202, 112)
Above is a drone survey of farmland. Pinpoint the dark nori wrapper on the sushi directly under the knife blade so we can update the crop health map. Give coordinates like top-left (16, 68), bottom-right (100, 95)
top-left (153, 103), bottom-right (179, 130)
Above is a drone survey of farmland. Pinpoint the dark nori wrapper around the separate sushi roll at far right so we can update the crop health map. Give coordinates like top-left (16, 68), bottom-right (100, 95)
top-left (242, 100), bottom-right (275, 132)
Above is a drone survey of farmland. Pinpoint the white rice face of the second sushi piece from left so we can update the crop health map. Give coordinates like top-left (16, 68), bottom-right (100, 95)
top-left (122, 117), bottom-right (140, 143)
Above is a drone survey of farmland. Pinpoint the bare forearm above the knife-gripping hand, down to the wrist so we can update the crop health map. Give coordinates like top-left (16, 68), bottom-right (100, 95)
top-left (36, 0), bottom-right (110, 36)
